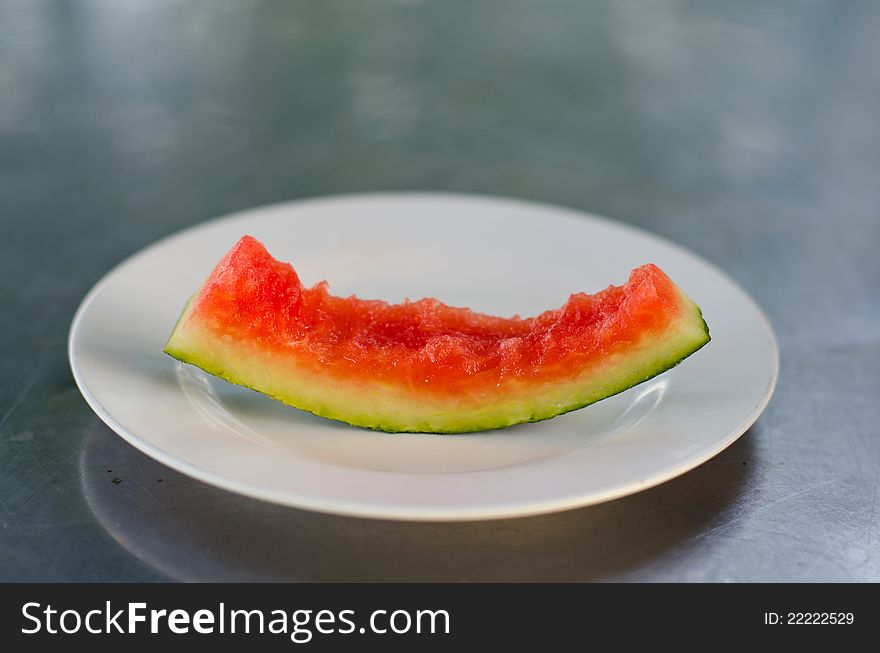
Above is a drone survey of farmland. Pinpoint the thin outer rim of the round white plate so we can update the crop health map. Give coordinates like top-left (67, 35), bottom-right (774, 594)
top-left (67, 191), bottom-right (780, 522)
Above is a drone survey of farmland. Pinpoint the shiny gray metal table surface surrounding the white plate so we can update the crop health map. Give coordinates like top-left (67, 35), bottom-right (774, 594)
top-left (0, 0), bottom-right (880, 581)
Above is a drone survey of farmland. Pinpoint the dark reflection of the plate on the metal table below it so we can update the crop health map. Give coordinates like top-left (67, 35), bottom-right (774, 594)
top-left (79, 419), bottom-right (754, 581)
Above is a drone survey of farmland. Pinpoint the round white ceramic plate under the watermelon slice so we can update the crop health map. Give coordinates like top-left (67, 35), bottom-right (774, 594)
top-left (69, 194), bottom-right (778, 520)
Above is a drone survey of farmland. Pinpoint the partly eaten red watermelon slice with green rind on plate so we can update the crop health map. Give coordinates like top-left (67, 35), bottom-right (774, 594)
top-left (165, 236), bottom-right (709, 433)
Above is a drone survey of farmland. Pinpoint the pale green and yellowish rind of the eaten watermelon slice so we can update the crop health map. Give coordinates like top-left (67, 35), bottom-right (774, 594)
top-left (165, 260), bottom-right (710, 433)
